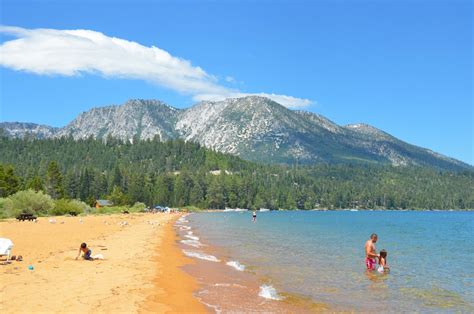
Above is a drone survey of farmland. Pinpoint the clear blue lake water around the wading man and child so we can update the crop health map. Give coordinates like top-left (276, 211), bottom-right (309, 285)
top-left (188, 211), bottom-right (474, 312)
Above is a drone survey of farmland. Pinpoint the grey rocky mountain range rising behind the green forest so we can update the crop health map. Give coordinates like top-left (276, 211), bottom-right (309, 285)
top-left (0, 96), bottom-right (474, 170)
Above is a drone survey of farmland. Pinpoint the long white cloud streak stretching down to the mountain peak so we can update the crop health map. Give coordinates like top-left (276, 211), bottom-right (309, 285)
top-left (0, 26), bottom-right (312, 107)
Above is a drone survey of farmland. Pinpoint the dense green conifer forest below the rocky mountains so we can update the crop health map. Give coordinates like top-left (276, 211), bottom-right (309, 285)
top-left (0, 137), bottom-right (474, 209)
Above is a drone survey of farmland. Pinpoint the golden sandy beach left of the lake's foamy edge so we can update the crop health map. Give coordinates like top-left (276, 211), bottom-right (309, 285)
top-left (0, 214), bottom-right (206, 313)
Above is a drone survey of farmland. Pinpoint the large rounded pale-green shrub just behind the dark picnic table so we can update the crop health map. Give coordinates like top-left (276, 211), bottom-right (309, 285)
top-left (9, 190), bottom-right (54, 215)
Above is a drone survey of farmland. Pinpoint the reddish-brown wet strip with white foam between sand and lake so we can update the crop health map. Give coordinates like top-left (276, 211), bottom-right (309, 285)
top-left (175, 213), bottom-right (330, 313)
